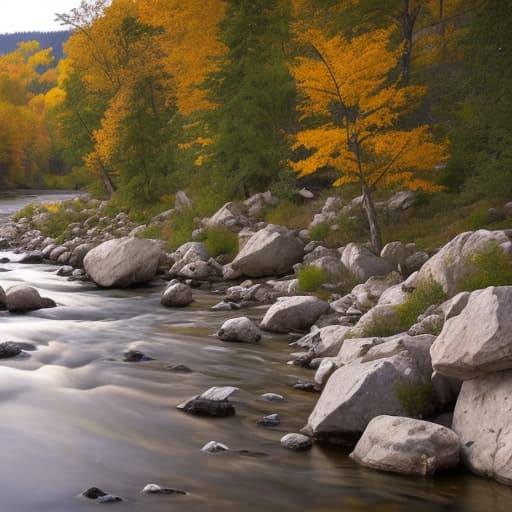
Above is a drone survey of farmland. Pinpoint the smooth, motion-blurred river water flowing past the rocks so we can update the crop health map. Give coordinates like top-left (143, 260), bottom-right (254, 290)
top-left (0, 196), bottom-right (512, 512)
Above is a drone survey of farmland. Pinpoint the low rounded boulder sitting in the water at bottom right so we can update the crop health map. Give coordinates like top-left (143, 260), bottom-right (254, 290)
top-left (350, 416), bottom-right (460, 475)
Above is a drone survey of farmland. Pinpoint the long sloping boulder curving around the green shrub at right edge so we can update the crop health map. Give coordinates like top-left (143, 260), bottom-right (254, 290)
top-left (418, 229), bottom-right (510, 296)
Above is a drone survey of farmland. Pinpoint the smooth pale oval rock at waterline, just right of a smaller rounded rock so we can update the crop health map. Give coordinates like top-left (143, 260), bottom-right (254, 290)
top-left (260, 296), bottom-right (330, 333)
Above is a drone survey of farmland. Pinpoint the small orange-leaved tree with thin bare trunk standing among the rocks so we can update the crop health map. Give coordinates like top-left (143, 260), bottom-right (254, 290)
top-left (292, 29), bottom-right (446, 251)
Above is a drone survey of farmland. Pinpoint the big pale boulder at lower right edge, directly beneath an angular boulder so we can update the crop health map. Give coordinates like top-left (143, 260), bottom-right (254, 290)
top-left (452, 371), bottom-right (512, 485)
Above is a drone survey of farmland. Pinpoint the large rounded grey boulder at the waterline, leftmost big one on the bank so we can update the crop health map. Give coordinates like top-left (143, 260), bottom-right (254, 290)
top-left (84, 237), bottom-right (162, 288)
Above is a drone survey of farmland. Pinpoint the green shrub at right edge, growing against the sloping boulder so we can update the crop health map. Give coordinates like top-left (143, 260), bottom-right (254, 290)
top-left (459, 243), bottom-right (512, 291)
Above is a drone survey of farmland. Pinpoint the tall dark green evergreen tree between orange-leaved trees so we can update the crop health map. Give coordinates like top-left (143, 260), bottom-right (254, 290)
top-left (208, 0), bottom-right (295, 196)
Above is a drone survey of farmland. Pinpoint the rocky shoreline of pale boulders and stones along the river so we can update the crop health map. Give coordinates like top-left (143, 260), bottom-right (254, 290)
top-left (0, 193), bottom-right (512, 485)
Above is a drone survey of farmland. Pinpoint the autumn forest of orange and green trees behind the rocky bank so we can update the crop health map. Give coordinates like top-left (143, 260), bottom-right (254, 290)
top-left (0, 0), bottom-right (512, 247)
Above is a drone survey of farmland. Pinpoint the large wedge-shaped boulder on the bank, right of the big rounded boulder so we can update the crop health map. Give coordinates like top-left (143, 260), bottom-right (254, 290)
top-left (231, 224), bottom-right (304, 277)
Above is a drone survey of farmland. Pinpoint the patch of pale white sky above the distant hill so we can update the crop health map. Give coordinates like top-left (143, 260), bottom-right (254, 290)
top-left (0, 0), bottom-right (80, 34)
